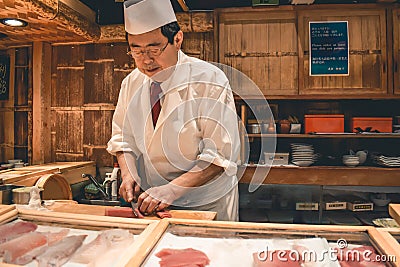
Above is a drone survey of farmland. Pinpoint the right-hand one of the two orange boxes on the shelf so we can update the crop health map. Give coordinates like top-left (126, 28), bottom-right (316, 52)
top-left (350, 117), bottom-right (393, 133)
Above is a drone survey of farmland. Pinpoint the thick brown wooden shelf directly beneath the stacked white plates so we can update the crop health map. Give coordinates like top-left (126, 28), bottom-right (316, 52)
top-left (238, 166), bottom-right (400, 186)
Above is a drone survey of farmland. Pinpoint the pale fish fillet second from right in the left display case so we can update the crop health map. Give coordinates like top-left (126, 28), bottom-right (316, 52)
top-left (36, 235), bottom-right (87, 267)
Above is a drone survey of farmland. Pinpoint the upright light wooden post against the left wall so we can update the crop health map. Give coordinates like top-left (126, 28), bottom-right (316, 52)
top-left (32, 42), bottom-right (51, 164)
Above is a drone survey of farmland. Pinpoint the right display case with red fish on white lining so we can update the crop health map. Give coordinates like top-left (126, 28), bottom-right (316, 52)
top-left (128, 219), bottom-right (400, 267)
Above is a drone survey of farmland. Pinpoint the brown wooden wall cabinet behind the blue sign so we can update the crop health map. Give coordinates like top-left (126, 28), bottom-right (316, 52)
top-left (216, 4), bottom-right (392, 98)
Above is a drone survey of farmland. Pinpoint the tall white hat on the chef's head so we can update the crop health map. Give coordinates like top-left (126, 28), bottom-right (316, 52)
top-left (124, 0), bottom-right (176, 34)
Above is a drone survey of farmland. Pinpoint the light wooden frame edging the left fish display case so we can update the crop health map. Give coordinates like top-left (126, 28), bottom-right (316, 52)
top-left (0, 205), bottom-right (157, 267)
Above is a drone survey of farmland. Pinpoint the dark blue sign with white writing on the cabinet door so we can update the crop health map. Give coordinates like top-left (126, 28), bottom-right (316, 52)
top-left (309, 21), bottom-right (349, 76)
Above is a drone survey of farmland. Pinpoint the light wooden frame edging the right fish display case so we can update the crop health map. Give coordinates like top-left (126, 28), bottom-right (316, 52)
top-left (127, 219), bottom-right (400, 267)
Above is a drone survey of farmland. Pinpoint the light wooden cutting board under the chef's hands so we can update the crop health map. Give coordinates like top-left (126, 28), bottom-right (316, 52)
top-left (46, 201), bottom-right (217, 220)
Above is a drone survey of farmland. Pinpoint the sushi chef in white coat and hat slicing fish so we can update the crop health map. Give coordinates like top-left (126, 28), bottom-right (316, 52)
top-left (107, 0), bottom-right (240, 221)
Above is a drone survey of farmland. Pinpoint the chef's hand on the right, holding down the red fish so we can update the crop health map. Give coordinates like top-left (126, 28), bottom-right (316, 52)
top-left (138, 184), bottom-right (180, 214)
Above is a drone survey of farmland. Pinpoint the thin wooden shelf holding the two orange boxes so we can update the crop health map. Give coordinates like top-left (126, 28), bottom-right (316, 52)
top-left (246, 133), bottom-right (400, 138)
